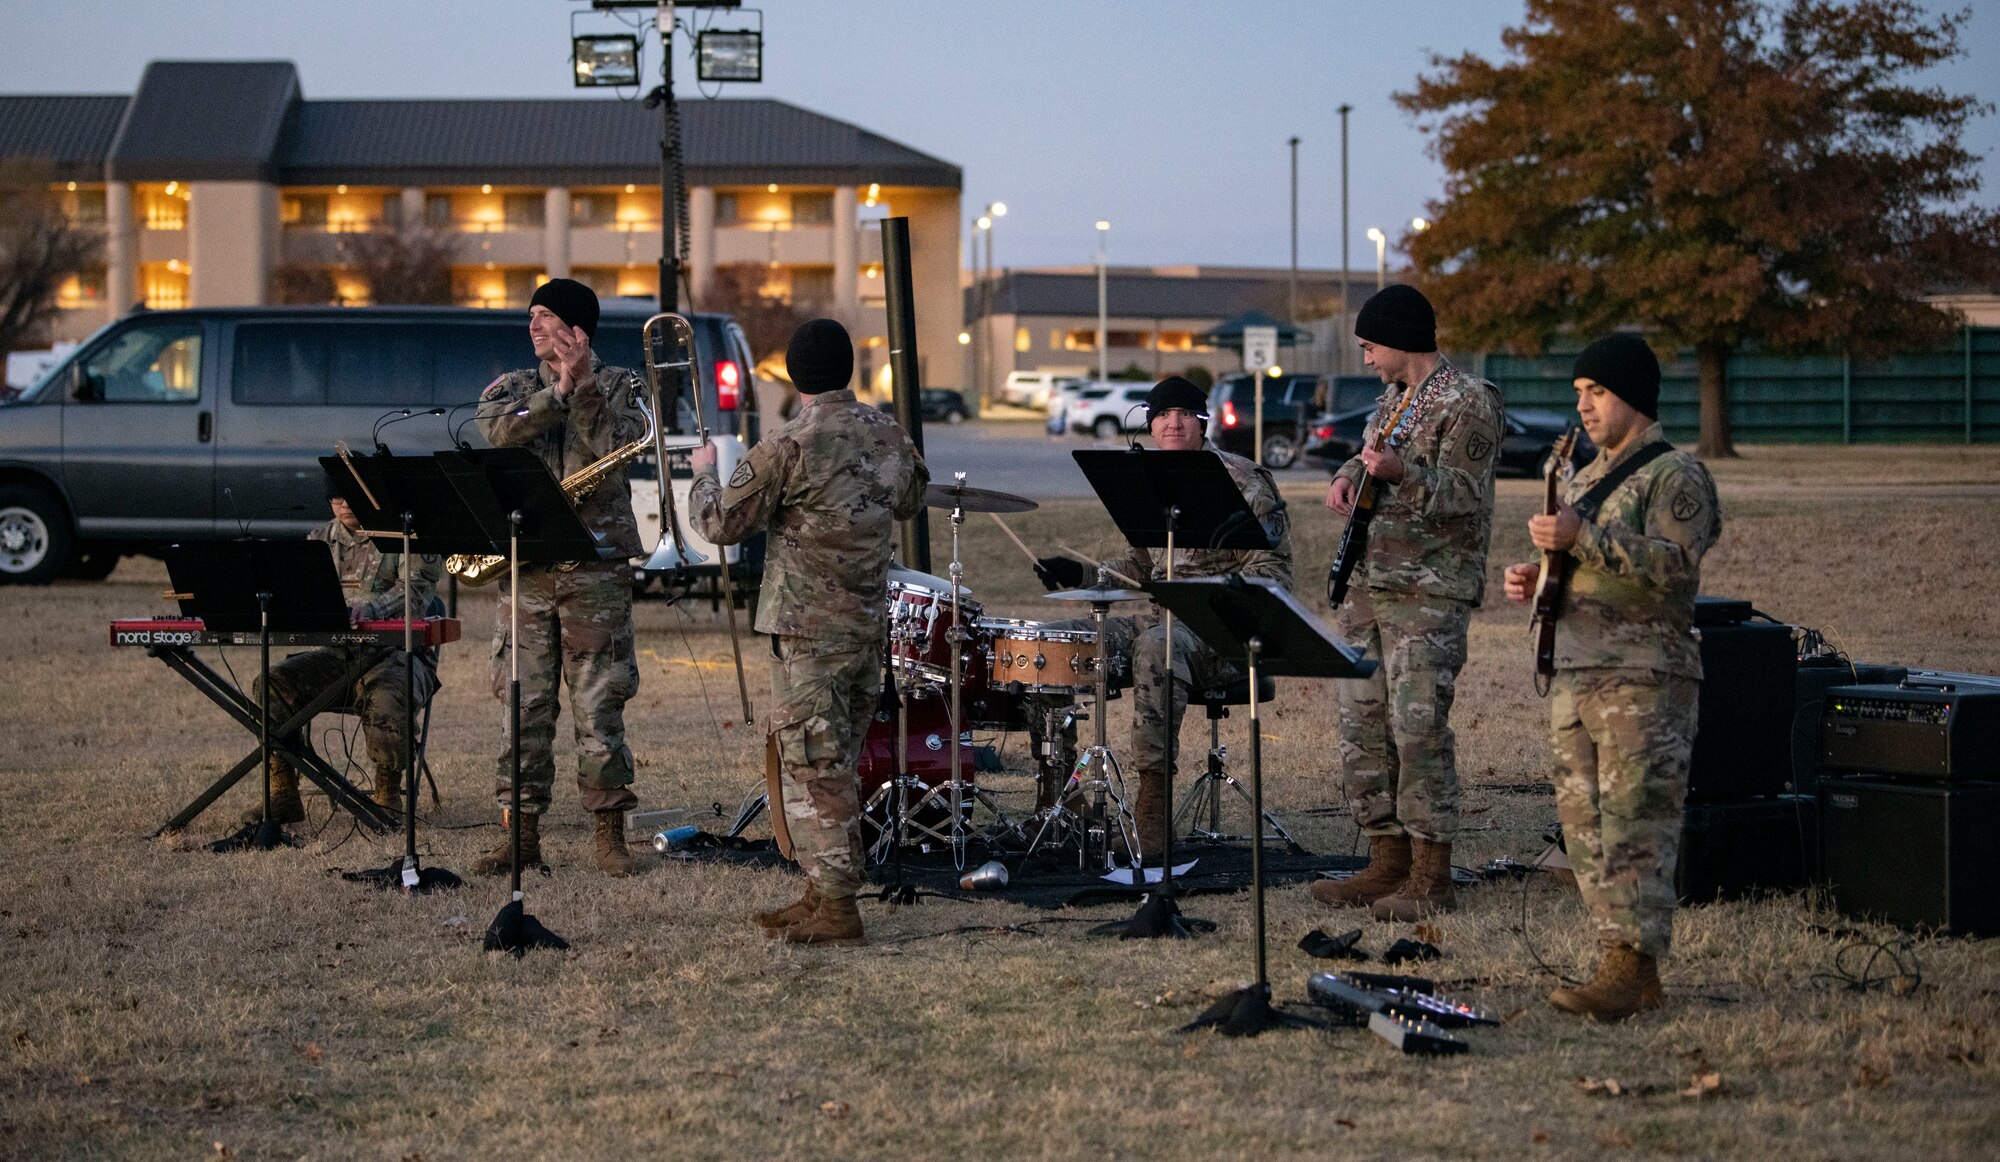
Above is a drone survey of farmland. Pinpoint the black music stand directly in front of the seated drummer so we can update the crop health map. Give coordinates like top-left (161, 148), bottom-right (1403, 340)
top-left (1072, 448), bottom-right (1270, 940)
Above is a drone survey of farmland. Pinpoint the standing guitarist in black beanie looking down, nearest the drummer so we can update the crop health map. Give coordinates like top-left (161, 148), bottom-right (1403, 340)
top-left (1312, 284), bottom-right (1502, 920)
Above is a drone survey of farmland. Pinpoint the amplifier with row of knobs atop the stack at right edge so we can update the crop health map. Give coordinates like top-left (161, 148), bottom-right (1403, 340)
top-left (1820, 672), bottom-right (2000, 782)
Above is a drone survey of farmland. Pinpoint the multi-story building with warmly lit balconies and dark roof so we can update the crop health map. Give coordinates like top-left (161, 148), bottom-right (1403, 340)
top-left (0, 62), bottom-right (964, 386)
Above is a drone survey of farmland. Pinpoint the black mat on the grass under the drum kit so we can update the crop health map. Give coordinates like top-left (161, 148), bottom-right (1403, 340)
top-left (666, 832), bottom-right (1368, 908)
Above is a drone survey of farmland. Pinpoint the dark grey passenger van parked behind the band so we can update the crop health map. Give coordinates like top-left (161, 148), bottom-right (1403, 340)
top-left (0, 300), bottom-right (758, 584)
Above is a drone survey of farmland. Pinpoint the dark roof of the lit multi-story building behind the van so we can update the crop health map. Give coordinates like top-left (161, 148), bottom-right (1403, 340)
top-left (0, 60), bottom-right (962, 190)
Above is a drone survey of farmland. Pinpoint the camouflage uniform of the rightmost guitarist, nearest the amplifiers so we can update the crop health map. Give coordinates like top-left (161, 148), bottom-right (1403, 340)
top-left (1550, 424), bottom-right (1722, 958)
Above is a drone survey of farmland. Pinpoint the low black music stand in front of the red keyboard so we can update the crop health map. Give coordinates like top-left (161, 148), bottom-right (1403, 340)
top-left (166, 540), bottom-right (352, 854)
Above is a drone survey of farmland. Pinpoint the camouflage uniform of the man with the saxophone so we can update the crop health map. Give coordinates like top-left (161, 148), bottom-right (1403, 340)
top-left (478, 354), bottom-right (646, 814)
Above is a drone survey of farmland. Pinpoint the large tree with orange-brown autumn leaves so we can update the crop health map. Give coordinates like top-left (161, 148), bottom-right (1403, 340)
top-left (1396, 0), bottom-right (2000, 456)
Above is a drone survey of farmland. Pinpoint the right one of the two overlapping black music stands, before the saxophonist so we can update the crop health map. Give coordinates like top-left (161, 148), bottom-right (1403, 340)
top-left (436, 448), bottom-right (616, 956)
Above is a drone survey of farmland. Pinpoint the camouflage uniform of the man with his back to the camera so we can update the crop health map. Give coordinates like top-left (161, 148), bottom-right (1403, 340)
top-left (688, 390), bottom-right (930, 900)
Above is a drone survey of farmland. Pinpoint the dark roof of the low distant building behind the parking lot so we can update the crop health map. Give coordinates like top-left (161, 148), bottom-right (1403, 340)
top-left (966, 270), bottom-right (1340, 320)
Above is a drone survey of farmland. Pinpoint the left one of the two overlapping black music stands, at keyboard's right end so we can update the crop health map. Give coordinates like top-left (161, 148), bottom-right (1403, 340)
top-left (320, 454), bottom-right (492, 896)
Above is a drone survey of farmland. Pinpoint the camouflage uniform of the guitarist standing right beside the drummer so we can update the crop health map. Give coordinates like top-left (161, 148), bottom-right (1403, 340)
top-left (1336, 356), bottom-right (1502, 844)
